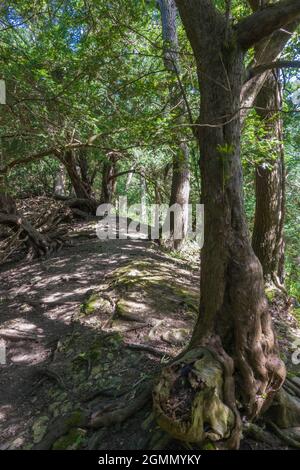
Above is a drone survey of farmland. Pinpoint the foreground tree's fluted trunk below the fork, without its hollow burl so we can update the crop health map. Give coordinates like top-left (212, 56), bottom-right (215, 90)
top-left (191, 43), bottom-right (284, 422)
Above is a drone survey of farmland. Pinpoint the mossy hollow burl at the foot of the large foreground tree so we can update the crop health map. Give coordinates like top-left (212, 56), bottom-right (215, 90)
top-left (153, 347), bottom-right (241, 448)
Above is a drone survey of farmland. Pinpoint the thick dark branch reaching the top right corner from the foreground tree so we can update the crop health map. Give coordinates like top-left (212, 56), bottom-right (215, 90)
top-left (236, 0), bottom-right (300, 49)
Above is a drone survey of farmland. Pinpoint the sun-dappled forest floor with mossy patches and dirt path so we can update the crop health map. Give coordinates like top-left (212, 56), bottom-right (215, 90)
top-left (0, 210), bottom-right (300, 450)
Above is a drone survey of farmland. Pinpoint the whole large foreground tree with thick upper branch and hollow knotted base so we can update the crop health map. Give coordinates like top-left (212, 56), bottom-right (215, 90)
top-left (154, 0), bottom-right (300, 448)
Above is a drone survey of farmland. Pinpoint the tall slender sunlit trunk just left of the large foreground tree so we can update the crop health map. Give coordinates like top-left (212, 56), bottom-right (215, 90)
top-left (158, 0), bottom-right (190, 248)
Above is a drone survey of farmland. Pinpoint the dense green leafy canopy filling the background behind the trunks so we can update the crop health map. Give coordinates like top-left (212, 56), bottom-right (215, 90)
top-left (0, 0), bottom-right (300, 296)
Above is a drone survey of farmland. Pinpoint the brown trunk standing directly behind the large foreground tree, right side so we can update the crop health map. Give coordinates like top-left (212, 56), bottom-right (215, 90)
top-left (252, 72), bottom-right (285, 284)
